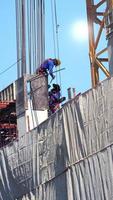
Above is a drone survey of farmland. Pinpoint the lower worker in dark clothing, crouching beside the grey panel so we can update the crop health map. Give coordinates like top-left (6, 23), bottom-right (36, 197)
top-left (49, 84), bottom-right (65, 113)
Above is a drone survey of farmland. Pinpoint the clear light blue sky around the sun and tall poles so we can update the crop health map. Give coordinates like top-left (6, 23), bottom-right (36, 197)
top-left (0, 0), bottom-right (91, 95)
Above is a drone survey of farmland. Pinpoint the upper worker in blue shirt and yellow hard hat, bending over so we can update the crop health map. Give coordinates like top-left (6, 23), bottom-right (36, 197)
top-left (36, 58), bottom-right (61, 79)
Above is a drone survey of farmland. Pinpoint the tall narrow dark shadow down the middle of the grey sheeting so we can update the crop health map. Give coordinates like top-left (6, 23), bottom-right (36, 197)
top-left (53, 110), bottom-right (69, 200)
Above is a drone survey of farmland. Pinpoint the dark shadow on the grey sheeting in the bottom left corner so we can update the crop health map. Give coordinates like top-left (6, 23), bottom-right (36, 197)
top-left (0, 146), bottom-right (32, 200)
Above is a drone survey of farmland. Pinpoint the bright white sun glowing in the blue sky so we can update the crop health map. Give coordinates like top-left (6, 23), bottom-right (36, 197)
top-left (71, 20), bottom-right (88, 42)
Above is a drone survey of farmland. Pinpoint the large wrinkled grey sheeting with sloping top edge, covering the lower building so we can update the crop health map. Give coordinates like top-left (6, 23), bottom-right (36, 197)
top-left (0, 78), bottom-right (113, 200)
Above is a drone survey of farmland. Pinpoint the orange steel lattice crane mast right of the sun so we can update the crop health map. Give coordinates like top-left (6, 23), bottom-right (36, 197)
top-left (86, 0), bottom-right (110, 87)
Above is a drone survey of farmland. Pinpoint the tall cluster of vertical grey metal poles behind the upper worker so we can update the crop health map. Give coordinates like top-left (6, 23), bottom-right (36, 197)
top-left (15, 0), bottom-right (45, 78)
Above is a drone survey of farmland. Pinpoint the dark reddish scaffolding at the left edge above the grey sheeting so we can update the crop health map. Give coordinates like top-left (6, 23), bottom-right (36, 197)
top-left (0, 101), bottom-right (18, 148)
